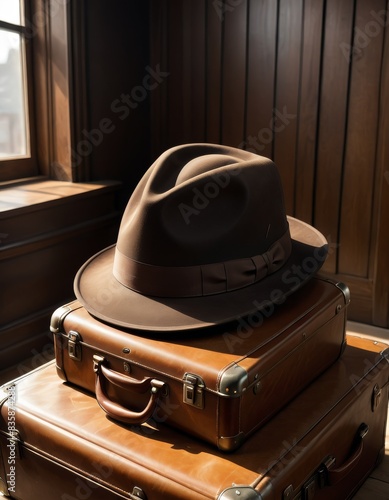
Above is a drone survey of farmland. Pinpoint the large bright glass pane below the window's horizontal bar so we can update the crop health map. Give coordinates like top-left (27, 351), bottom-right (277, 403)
top-left (0, 30), bottom-right (27, 158)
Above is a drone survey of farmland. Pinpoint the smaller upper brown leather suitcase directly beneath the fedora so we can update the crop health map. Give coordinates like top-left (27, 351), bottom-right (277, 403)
top-left (51, 278), bottom-right (349, 451)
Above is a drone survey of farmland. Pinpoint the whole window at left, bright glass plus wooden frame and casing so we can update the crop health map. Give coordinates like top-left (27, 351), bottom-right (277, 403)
top-left (0, 0), bottom-right (87, 183)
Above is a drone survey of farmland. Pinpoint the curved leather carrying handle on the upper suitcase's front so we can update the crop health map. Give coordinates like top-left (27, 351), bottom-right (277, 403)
top-left (93, 355), bottom-right (166, 424)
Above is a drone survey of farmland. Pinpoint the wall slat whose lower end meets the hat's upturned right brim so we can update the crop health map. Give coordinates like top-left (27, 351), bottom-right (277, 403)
top-left (294, 0), bottom-right (324, 224)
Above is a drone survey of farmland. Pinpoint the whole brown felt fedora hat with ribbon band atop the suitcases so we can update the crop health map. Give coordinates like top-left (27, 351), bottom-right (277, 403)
top-left (74, 144), bottom-right (328, 332)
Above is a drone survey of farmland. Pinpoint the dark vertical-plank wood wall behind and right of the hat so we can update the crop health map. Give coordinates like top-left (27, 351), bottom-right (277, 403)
top-left (150, 0), bottom-right (389, 326)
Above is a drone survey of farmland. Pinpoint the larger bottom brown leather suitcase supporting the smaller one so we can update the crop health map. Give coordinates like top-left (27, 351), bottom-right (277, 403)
top-left (0, 337), bottom-right (389, 500)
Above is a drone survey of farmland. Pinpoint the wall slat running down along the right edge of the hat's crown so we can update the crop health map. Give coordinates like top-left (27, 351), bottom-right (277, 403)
top-left (274, 0), bottom-right (303, 214)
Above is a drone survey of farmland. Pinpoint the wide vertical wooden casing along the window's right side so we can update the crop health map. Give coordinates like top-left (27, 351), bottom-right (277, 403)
top-left (33, 0), bottom-right (89, 182)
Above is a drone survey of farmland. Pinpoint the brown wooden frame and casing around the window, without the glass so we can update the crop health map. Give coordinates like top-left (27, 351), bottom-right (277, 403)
top-left (0, 0), bottom-right (83, 184)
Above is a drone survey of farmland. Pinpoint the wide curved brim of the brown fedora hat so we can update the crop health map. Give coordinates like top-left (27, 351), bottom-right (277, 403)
top-left (74, 217), bottom-right (328, 332)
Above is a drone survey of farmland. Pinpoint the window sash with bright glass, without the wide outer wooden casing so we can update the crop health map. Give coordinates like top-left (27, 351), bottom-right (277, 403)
top-left (0, 0), bottom-right (36, 181)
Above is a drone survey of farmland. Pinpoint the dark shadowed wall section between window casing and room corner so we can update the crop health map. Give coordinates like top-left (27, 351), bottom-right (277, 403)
top-left (80, 0), bottom-right (150, 202)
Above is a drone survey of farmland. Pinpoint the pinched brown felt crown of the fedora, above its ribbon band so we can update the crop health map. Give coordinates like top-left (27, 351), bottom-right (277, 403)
top-left (113, 145), bottom-right (288, 266)
